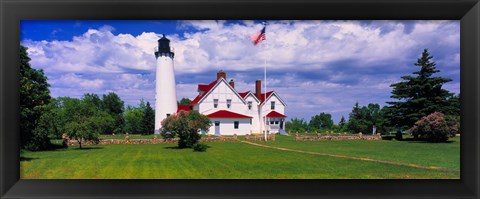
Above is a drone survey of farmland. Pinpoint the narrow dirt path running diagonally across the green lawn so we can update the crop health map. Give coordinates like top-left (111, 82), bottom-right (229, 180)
top-left (241, 141), bottom-right (460, 172)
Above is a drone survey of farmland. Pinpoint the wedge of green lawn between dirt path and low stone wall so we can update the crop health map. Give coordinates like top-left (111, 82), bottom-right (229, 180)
top-left (246, 136), bottom-right (460, 170)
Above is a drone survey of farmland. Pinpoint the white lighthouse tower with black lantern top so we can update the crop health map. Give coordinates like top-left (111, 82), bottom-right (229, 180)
top-left (155, 34), bottom-right (178, 134)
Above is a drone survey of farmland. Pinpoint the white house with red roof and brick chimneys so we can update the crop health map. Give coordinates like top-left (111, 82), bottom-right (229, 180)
top-left (177, 71), bottom-right (286, 135)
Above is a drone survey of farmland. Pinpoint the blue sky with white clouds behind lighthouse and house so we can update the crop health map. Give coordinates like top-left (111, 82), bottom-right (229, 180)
top-left (20, 20), bottom-right (460, 122)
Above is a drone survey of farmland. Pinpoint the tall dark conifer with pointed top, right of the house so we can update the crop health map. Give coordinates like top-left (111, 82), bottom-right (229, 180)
top-left (387, 49), bottom-right (454, 128)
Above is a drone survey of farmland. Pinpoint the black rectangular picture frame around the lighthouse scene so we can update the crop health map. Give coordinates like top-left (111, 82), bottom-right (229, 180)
top-left (0, 0), bottom-right (480, 198)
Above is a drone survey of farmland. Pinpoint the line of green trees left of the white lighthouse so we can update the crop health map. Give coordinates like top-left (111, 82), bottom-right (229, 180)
top-left (20, 46), bottom-right (155, 151)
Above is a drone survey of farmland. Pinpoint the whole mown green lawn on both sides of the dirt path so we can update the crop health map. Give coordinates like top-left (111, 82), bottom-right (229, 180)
top-left (20, 136), bottom-right (460, 179)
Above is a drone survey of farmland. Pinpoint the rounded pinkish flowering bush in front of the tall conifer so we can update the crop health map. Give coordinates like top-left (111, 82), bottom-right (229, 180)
top-left (409, 112), bottom-right (460, 142)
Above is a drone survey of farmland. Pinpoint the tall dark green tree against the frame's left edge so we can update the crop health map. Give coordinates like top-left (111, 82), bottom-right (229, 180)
top-left (20, 46), bottom-right (50, 150)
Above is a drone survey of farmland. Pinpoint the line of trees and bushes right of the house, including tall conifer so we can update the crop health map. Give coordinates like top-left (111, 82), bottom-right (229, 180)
top-left (286, 49), bottom-right (460, 141)
